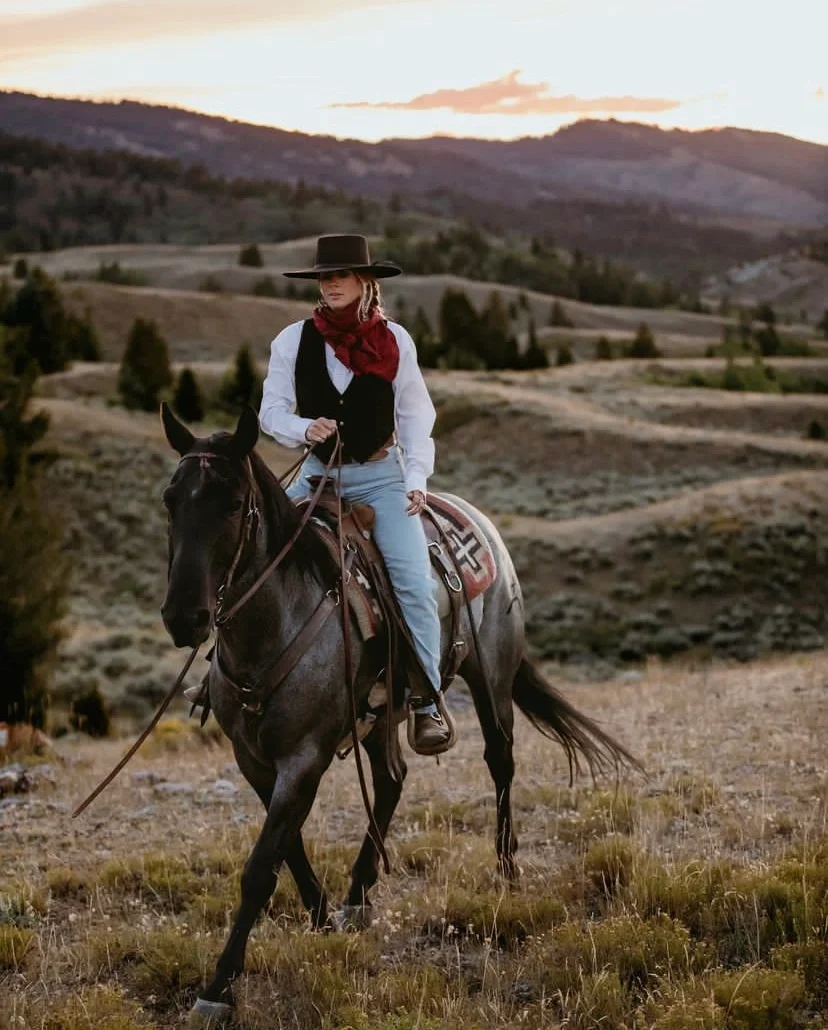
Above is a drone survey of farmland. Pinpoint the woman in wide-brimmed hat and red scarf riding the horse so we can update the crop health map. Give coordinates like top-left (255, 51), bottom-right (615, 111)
top-left (258, 235), bottom-right (452, 755)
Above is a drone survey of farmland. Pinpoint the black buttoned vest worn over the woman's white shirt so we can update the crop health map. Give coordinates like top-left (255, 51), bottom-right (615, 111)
top-left (295, 318), bottom-right (394, 462)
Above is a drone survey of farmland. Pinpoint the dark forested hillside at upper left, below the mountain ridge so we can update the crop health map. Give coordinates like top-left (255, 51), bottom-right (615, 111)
top-left (0, 133), bottom-right (387, 260)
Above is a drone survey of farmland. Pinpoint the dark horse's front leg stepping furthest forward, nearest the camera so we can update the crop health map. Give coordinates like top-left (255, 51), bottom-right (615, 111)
top-left (193, 741), bottom-right (331, 1026)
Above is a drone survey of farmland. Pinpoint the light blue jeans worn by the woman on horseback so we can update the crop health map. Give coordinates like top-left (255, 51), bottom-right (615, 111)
top-left (287, 446), bottom-right (440, 690)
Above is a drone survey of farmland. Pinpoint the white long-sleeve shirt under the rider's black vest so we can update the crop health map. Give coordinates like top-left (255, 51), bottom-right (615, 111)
top-left (258, 321), bottom-right (436, 492)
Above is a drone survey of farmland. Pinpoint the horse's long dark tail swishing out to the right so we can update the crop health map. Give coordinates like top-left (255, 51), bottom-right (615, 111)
top-left (512, 657), bottom-right (643, 783)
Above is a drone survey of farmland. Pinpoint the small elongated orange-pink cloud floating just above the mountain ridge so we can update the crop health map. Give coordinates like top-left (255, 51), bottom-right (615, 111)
top-left (330, 70), bottom-right (681, 114)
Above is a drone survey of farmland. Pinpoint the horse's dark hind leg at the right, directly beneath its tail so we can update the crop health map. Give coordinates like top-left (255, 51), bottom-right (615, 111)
top-left (460, 656), bottom-right (518, 881)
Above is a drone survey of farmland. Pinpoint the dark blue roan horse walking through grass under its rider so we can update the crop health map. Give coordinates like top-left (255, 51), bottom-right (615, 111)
top-left (162, 406), bottom-right (634, 1026)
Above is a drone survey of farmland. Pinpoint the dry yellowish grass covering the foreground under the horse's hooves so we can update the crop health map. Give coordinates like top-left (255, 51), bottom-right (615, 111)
top-left (0, 654), bottom-right (828, 1030)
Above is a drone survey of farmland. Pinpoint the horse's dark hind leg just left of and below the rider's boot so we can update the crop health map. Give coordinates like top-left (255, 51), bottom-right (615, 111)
top-left (343, 719), bottom-right (407, 925)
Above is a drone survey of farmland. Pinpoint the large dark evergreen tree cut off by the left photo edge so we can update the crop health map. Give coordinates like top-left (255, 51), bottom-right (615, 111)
top-left (0, 325), bottom-right (68, 727)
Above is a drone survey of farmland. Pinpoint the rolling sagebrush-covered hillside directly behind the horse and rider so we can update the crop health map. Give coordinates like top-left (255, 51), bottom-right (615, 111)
top-left (39, 341), bottom-right (828, 713)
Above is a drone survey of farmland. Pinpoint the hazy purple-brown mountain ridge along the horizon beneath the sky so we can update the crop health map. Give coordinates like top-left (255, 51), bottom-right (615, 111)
top-left (0, 92), bottom-right (828, 229)
